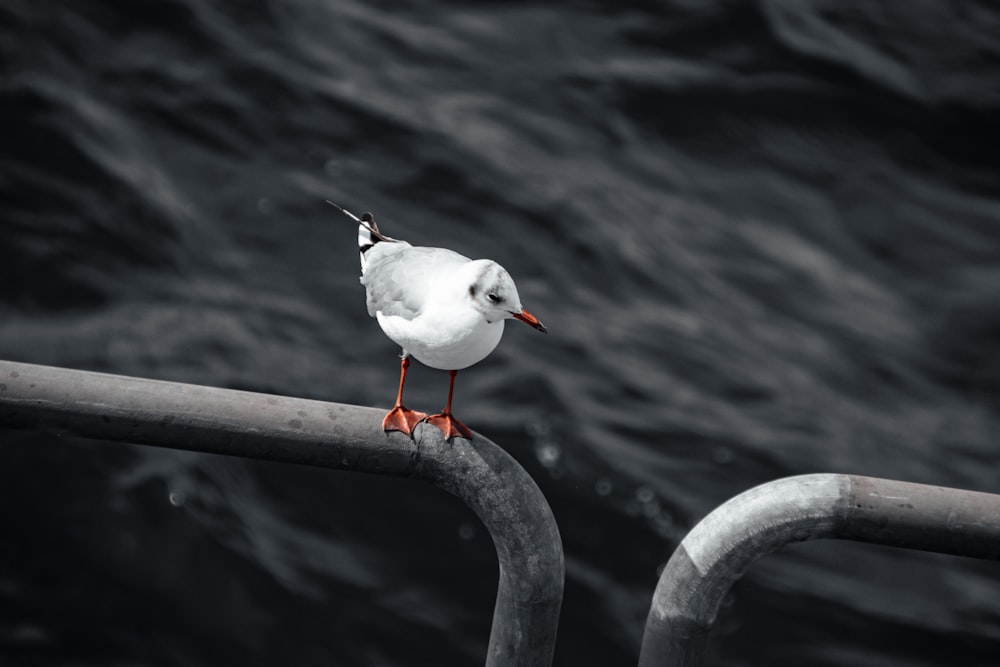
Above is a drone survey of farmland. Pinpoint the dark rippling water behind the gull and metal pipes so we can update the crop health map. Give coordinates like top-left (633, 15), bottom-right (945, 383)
top-left (0, 0), bottom-right (1000, 666)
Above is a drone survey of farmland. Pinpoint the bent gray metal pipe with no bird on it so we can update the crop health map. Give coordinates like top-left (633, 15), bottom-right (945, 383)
top-left (639, 474), bottom-right (1000, 667)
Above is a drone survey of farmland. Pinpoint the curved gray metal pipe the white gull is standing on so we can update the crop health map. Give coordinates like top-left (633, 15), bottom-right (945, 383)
top-left (0, 361), bottom-right (564, 667)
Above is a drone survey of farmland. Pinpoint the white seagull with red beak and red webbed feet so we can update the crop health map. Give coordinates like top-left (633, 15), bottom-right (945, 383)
top-left (327, 200), bottom-right (547, 440)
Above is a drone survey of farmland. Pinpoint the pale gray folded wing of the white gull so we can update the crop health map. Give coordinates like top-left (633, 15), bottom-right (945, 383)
top-left (361, 243), bottom-right (469, 320)
